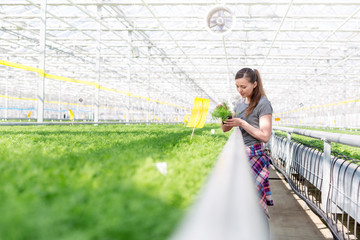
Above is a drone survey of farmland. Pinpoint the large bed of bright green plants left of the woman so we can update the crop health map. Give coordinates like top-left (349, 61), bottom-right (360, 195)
top-left (0, 125), bottom-right (228, 240)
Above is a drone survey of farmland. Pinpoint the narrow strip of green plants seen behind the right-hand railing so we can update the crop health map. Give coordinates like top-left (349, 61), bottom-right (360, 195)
top-left (275, 131), bottom-right (360, 160)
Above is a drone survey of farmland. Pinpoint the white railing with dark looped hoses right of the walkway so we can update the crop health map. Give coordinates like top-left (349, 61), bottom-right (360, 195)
top-left (267, 127), bottom-right (360, 239)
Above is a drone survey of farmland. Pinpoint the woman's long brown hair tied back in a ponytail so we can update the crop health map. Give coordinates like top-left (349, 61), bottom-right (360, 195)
top-left (235, 68), bottom-right (266, 117)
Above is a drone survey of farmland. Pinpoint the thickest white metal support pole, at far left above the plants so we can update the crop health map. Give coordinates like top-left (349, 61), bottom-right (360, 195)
top-left (37, 0), bottom-right (47, 123)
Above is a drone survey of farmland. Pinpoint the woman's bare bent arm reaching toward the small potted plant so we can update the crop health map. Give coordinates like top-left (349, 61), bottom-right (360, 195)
top-left (221, 114), bottom-right (272, 143)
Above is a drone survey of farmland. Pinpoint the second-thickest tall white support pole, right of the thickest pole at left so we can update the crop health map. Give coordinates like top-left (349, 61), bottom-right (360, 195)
top-left (94, 5), bottom-right (101, 123)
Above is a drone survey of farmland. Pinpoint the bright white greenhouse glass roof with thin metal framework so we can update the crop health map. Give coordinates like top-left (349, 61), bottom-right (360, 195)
top-left (0, 0), bottom-right (360, 120)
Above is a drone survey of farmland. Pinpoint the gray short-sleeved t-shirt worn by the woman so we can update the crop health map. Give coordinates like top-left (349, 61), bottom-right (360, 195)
top-left (234, 96), bottom-right (273, 146)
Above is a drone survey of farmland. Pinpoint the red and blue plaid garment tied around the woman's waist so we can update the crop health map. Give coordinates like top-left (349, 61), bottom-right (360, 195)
top-left (247, 143), bottom-right (274, 217)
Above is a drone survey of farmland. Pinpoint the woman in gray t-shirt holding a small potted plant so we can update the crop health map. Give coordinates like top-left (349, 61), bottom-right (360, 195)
top-left (221, 68), bottom-right (274, 217)
